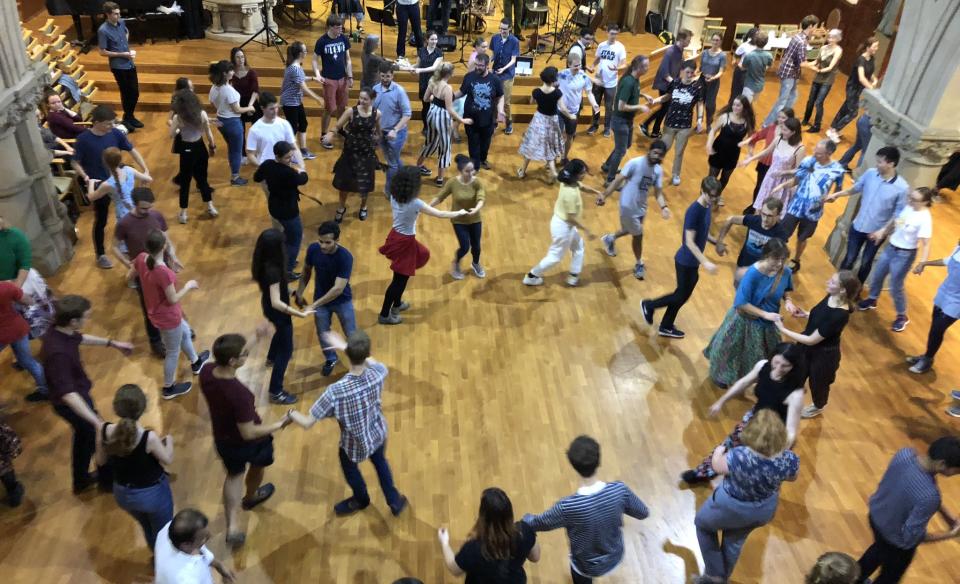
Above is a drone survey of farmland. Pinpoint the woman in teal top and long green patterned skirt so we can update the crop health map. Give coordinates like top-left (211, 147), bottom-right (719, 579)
top-left (703, 239), bottom-right (805, 389)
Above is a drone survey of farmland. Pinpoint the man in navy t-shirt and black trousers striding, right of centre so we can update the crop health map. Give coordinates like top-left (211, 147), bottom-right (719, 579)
top-left (640, 176), bottom-right (720, 339)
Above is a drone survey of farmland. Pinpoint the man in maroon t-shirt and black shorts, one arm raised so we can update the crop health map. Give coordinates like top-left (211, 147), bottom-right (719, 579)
top-left (200, 323), bottom-right (291, 546)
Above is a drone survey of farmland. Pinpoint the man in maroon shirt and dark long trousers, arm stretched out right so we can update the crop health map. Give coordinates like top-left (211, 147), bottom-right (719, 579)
top-left (42, 294), bottom-right (133, 493)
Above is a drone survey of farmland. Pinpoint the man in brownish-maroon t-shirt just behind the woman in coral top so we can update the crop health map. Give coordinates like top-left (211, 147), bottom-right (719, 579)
top-left (113, 187), bottom-right (183, 357)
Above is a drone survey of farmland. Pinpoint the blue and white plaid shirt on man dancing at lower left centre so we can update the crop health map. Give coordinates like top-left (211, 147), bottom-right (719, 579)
top-left (310, 363), bottom-right (387, 463)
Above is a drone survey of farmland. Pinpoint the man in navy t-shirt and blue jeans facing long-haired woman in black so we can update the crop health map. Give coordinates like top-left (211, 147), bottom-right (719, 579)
top-left (296, 221), bottom-right (357, 376)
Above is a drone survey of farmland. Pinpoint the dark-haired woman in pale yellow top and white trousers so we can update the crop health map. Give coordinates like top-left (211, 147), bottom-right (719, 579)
top-left (523, 158), bottom-right (600, 286)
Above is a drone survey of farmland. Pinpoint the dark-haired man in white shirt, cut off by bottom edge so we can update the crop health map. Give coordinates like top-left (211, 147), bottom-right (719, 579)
top-left (153, 509), bottom-right (235, 584)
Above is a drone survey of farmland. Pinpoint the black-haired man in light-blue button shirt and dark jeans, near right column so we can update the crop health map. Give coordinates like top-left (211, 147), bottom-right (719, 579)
top-left (825, 146), bottom-right (910, 284)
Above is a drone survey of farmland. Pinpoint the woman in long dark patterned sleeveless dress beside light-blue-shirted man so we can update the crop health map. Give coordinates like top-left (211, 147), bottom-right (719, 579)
top-left (323, 87), bottom-right (380, 223)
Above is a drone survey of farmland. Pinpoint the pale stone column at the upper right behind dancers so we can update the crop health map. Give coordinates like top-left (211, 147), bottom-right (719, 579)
top-left (825, 0), bottom-right (960, 265)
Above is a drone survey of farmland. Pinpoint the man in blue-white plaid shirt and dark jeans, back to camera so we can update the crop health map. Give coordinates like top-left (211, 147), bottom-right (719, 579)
top-left (290, 330), bottom-right (407, 517)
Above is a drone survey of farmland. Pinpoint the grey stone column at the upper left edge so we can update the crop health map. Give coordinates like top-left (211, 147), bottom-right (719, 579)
top-left (0, 0), bottom-right (73, 275)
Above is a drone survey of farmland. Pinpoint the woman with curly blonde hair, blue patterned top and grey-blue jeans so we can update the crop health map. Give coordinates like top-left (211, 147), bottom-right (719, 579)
top-left (692, 409), bottom-right (800, 584)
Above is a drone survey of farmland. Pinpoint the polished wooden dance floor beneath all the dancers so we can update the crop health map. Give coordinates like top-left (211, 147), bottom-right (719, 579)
top-left (7, 6), bottom-right (960, 584)
